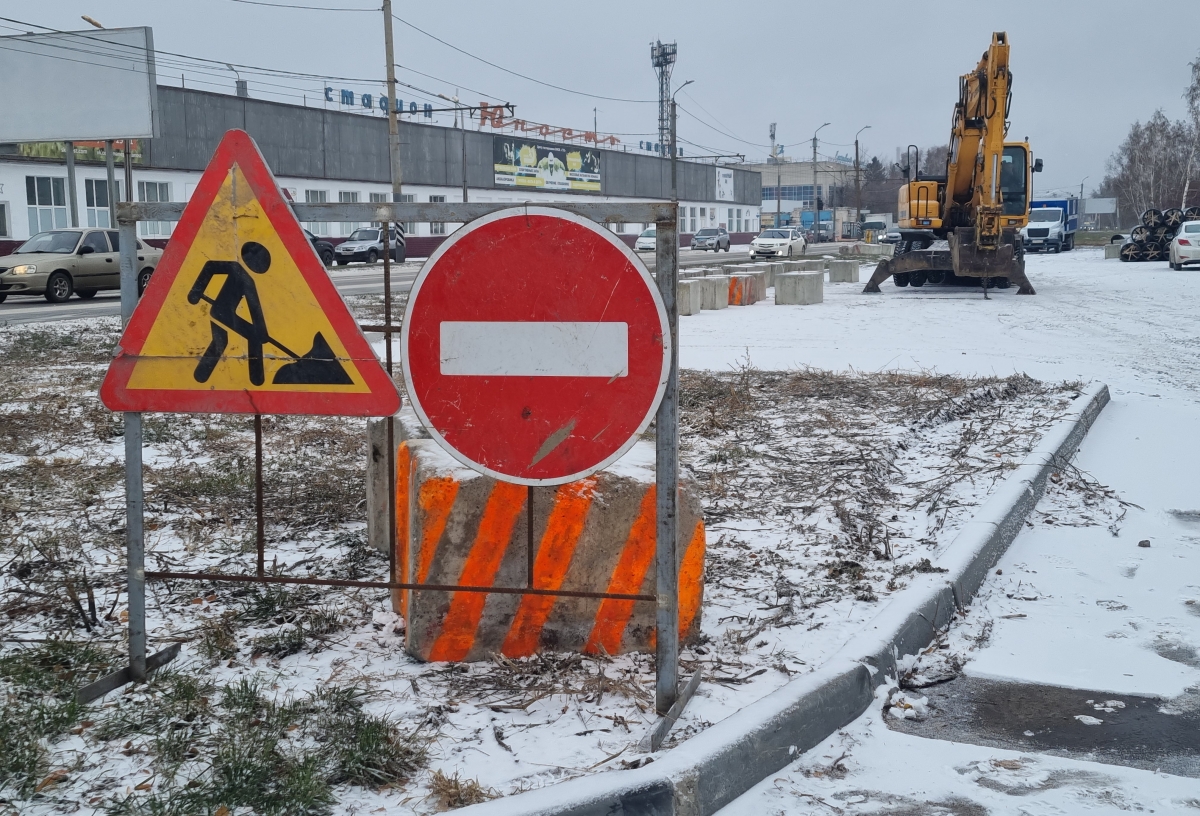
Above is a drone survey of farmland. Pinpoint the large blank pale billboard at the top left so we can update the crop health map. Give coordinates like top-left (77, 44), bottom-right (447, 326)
top-left (0, 26), bottom-right (158, 142)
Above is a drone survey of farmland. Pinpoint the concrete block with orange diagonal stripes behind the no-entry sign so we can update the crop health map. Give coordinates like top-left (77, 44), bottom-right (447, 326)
top-left (392, 439), bottom-right (704, 660)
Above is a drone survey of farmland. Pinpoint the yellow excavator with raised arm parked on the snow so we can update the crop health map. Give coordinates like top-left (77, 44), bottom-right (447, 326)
top-left (863, 31), bottom-right (1042, 296)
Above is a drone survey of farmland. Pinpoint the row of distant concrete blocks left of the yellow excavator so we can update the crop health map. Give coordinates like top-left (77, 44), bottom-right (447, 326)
top-left (676, 258), bottom-right (859, 317)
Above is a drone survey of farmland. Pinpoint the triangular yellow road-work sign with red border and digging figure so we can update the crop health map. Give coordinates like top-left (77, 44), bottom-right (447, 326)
top-left (100, 131), bottom-right (400, 416)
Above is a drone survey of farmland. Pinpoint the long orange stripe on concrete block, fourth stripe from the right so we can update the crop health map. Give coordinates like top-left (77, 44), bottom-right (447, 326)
top-left (430, 481), bottom-right (528, 660)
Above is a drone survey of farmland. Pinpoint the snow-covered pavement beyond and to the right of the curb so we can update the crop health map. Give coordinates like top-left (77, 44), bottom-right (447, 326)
top-left (710, 248), bottom-right (1200, 814)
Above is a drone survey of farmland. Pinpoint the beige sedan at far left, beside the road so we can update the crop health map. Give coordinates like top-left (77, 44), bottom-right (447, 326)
top-left (0, 229), bottom-right (162, 304)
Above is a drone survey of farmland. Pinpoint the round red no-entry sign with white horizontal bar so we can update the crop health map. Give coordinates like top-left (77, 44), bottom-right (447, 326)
top-left (401, 206), bottom-right (671, 485)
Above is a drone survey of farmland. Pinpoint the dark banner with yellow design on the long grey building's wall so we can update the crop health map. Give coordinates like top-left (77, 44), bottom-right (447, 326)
top-left (492, 136), bottom-right (600, 193)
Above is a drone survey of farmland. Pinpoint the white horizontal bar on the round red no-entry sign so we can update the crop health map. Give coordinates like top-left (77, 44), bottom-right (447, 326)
top-left (439, 320), bottom-right (629, 378)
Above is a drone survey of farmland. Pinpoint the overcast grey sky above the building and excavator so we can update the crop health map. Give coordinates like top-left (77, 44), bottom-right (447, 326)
top-left (0, 0), bottom-right (1200, 191)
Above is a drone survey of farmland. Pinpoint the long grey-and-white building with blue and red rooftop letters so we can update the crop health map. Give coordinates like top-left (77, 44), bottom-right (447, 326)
top-left (0, 85), bottom-right (762, 256)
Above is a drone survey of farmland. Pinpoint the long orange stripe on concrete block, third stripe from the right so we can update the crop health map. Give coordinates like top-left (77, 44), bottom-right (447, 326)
top-left (500, 479), bottom-right (596, 658)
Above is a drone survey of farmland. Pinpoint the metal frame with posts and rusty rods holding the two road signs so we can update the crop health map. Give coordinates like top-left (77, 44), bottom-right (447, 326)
top-left (110, 202), bottom-right (696, 719)
